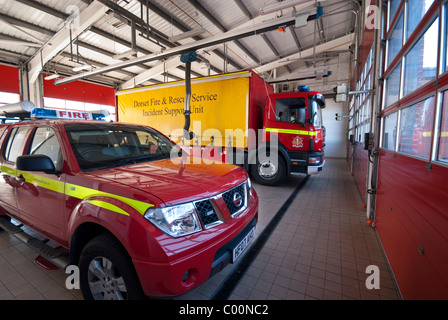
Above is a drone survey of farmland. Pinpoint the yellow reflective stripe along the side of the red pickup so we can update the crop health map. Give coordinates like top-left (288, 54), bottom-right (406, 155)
top-left (0, 166), bottom-right (153, 215)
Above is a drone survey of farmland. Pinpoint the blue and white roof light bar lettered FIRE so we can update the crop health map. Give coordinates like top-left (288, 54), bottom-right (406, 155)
top-left (30, 108), bottom-right (110, 121)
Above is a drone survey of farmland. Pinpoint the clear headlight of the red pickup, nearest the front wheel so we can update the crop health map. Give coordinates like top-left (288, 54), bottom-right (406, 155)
top-left (145, 203), bottom-right (201, 237)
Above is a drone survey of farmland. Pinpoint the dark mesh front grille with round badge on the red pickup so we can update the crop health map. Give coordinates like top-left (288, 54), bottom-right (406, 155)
top-left (194, 182), bottom-right (248, 228)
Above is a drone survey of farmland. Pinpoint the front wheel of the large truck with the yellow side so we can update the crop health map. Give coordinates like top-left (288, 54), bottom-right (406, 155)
top-left (251, 155), bottom-right (286, 186)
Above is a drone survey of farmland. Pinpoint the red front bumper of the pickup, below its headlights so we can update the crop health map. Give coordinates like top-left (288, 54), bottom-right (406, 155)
top-left (133, 195), bottom-right (258, 297)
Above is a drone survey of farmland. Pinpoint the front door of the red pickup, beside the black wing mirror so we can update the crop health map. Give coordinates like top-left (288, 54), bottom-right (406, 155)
top-left (17, 126), bottom-right (65, 239)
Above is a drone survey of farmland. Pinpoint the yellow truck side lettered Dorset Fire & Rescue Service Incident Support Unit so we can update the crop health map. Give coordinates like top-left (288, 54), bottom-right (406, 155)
top-left (117, 71), bottom-right (262, 148)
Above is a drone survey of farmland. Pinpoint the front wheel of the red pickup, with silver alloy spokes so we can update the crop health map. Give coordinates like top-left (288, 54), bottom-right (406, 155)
top-left (79, 234), bottom-right (145, 300)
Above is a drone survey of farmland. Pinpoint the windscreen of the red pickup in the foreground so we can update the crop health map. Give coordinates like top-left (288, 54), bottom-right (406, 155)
top-left (65, 123), bottom-right (180, 171)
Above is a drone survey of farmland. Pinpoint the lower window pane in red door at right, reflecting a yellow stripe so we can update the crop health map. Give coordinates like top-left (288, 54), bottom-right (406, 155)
top-left (398, 96), bottom-right (434, 159)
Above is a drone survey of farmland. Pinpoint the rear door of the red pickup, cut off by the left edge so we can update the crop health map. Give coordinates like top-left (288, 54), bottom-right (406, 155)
top-left (0, 126), bottom-right (30, 219)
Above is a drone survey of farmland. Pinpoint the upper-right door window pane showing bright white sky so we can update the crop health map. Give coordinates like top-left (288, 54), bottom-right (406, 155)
top-left (403, 19), bottom-right (439, 95)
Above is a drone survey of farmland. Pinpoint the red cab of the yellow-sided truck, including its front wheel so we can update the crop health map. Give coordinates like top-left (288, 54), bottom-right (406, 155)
top-left (252, 86), bottom-right (325, 183)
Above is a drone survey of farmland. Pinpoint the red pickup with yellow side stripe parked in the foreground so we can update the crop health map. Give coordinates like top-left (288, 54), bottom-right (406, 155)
top-left (0, 109), bottom-right (258, 299)
